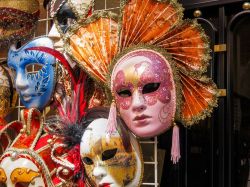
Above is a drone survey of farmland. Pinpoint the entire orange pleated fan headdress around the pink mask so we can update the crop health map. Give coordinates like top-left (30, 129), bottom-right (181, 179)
top-left (65, 0), bottom-right (218, 126)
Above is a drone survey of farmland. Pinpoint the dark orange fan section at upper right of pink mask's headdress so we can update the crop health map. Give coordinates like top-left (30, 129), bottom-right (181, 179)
top-left (153, 20), bottom-right (210, 74)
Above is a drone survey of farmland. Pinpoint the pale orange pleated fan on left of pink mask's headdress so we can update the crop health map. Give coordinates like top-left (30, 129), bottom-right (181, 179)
top-left (66, 17), bottom-right (118, 83)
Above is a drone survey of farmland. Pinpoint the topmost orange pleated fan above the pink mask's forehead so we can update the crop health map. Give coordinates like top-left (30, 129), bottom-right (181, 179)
top-left (120, 0), bottom-right (182, 50)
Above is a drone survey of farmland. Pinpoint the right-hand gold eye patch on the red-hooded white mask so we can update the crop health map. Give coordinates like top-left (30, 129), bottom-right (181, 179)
top-left (10, 168), bottom-right (41, 184)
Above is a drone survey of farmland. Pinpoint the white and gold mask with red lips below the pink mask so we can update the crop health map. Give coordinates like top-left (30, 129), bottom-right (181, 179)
top-left (80, 118), bottom-right (143, 187)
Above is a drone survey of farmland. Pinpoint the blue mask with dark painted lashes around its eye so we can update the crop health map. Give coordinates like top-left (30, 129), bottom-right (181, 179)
top-left (8, 37), bottom-right (56, 110)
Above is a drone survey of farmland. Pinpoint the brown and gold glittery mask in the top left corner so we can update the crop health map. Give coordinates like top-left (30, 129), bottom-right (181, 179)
top-left (0, 0), bottom-right (39, 46)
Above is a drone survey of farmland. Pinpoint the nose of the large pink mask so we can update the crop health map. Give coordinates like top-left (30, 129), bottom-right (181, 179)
top-left (132, 90), bottom-right (147, 112)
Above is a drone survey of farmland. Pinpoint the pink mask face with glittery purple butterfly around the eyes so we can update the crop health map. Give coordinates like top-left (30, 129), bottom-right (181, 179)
top-left (111, 49), bottom-right (176, 137)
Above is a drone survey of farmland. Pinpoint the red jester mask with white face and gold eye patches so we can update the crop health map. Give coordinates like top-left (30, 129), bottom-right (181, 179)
top-left (0, 108), bottom-right (65, 187)
